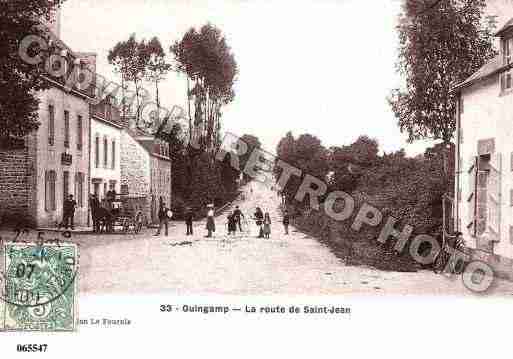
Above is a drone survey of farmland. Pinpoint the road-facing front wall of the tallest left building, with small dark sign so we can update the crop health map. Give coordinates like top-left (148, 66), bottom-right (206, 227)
top-left (34, 87), bottom-right (90, 227)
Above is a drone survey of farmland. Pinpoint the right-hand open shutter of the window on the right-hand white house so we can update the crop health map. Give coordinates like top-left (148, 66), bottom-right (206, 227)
top-left (487, 153), bottom-right (502, 240)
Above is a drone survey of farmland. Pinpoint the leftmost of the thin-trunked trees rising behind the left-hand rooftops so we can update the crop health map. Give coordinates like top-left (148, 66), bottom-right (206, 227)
top-left (107, 34), bottom-right (150, 122)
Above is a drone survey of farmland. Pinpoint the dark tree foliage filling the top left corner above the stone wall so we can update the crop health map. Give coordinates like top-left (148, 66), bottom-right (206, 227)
top-left (0, 0), bottom-right (64, 143)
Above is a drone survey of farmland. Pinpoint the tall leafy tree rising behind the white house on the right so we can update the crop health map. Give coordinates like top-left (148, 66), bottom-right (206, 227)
top-left (389, 0), bottom-right (495, 143)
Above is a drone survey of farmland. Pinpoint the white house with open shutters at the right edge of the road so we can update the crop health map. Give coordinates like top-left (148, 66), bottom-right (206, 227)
top-left (454, 13), bottom-right (513, 258)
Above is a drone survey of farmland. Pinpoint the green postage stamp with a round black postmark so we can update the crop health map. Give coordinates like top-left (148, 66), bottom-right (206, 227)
top-left (0, 243), bottom-right (79, 332)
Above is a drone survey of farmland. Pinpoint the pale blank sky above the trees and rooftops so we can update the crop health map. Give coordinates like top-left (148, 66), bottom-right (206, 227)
top-left (61, 0), bottom-right (430, 155)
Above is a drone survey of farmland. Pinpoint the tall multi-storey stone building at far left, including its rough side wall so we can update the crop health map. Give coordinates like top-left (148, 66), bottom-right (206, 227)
top-left (0, 12), bottom-right (92, 227)
